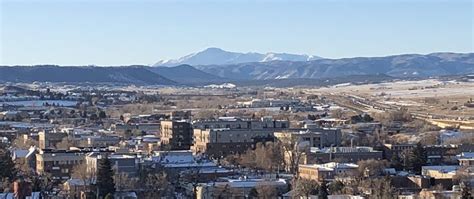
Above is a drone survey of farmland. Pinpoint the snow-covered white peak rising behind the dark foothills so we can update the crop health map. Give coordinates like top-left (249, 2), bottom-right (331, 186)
top-left (153, 48), bottom-right (320, 66)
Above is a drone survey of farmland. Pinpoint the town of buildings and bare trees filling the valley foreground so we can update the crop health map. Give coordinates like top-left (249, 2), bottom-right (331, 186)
top-left (0, 82), bottom-right (474, 199)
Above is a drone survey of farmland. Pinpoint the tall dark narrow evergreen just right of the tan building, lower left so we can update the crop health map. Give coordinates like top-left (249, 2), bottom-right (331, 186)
top-left (96, 157), bottom-right (115, 197)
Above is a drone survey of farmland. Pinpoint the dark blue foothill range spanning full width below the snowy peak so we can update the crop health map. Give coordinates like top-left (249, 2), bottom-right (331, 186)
top-left (0, 52), bottom-right (474, 85)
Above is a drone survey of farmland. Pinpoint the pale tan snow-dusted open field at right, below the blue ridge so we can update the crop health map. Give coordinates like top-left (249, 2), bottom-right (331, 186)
top-left (309, 79), bottom-right (474, 126)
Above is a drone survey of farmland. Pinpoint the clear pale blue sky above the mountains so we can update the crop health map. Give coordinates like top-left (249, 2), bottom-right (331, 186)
top-left (0, 0), bottom-right (474, 65)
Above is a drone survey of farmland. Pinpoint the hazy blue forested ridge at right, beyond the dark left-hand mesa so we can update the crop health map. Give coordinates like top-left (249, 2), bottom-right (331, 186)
top-left (195, 53), bottom-right (474, 80)
